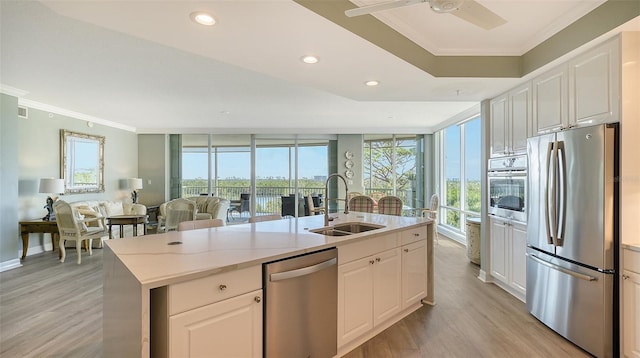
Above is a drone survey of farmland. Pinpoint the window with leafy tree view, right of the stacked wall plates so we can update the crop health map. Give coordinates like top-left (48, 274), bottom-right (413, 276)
top-left (363, 135), bottom-right (424, 207)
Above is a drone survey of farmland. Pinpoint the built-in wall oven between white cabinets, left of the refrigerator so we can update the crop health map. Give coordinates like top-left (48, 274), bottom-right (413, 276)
top-left (487, 155), bottom-right (527, 222)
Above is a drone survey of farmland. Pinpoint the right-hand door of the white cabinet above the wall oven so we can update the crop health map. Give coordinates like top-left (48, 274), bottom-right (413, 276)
top-left (508, 82), bottom-right (532, 154)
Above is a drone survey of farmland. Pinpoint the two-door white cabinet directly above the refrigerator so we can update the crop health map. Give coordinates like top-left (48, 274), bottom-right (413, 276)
top-left (533, 38), bottom-right (620, 134)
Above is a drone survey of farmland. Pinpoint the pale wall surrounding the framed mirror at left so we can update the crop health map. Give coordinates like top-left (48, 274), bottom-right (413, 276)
top-left (14, 103), bottom-right (138, 256)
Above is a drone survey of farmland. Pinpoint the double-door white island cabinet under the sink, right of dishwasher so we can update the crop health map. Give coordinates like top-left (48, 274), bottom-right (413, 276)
top-left (338, 248), bottom-right (402, 346)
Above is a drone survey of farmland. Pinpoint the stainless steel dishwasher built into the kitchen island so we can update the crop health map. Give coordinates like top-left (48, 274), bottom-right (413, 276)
top-left (263, 248), bottom-right (338, 358)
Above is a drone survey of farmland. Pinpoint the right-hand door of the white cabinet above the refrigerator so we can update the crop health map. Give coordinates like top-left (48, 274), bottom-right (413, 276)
top-left (569, 39), bottom-right (620, 125)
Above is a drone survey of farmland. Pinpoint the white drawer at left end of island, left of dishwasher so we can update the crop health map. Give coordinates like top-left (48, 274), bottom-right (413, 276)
top-left (169, 265), bottom-right (262, 315)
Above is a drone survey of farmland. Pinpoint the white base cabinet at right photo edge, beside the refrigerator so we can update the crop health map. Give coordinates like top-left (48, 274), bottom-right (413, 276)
top-left (621, 249), bottom-right (640, 358)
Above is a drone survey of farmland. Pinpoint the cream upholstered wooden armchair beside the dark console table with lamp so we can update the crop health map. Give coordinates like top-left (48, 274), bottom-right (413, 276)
top-left (53, 200), bottom-right (109, 265)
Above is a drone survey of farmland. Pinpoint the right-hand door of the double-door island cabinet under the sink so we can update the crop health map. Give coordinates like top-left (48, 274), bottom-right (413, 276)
top-left (373, 248), bottom-right (402, 326)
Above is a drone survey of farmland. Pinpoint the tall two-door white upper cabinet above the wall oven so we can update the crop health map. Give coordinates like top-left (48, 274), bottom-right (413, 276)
top-left (490, 82), bottom-right (532, 157)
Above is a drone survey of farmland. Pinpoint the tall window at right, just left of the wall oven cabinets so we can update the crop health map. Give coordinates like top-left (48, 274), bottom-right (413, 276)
top-left (438, 117), bottom-right (481, 238)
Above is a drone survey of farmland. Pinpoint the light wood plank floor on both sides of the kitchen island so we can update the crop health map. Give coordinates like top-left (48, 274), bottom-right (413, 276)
top-left (0, 237), bottom-right (589, 358)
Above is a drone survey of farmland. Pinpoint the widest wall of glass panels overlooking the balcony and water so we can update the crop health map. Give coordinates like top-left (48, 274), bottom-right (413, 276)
top-left (181, 134), bottom-right (331, 216)
